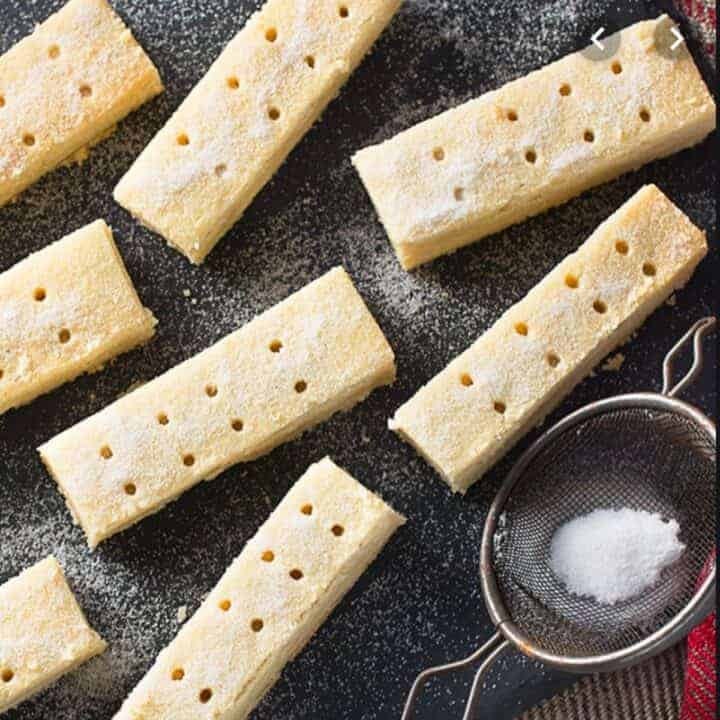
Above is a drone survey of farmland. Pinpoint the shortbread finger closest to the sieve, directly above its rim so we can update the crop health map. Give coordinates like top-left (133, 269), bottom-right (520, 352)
top-left (390, 185), bottom-right (707, 492)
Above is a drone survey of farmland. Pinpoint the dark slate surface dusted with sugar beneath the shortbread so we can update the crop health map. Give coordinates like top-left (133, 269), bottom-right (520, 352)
top-left (0, 0), bottom-right (720, 720)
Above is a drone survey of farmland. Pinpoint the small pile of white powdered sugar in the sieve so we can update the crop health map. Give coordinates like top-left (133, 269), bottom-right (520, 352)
top-left (550, 508), bottom-right (685, 605)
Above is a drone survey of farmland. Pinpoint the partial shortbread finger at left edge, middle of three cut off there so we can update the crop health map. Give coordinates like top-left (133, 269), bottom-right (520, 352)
top-left (0, 220), bottom-right (156, 420)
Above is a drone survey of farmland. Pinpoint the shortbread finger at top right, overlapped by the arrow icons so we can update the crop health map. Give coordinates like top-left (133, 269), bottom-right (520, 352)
top-left (353, 16), bottom-right (715, 270)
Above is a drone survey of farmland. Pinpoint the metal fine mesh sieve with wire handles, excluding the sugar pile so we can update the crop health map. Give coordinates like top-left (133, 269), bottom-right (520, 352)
top-left (402, 318), bottom-right (716, 720)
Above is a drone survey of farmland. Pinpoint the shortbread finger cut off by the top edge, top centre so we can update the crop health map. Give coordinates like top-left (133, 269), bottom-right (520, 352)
top-left (115, 0), bottom-right (402, 263)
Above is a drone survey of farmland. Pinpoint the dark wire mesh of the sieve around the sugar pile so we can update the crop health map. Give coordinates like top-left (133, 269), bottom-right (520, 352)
top-left (493, 406), bottom-right (716, 658)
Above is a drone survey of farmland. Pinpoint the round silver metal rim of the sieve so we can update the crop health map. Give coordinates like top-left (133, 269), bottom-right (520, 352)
top-left (480, 392), bottom-right (716, 673)
